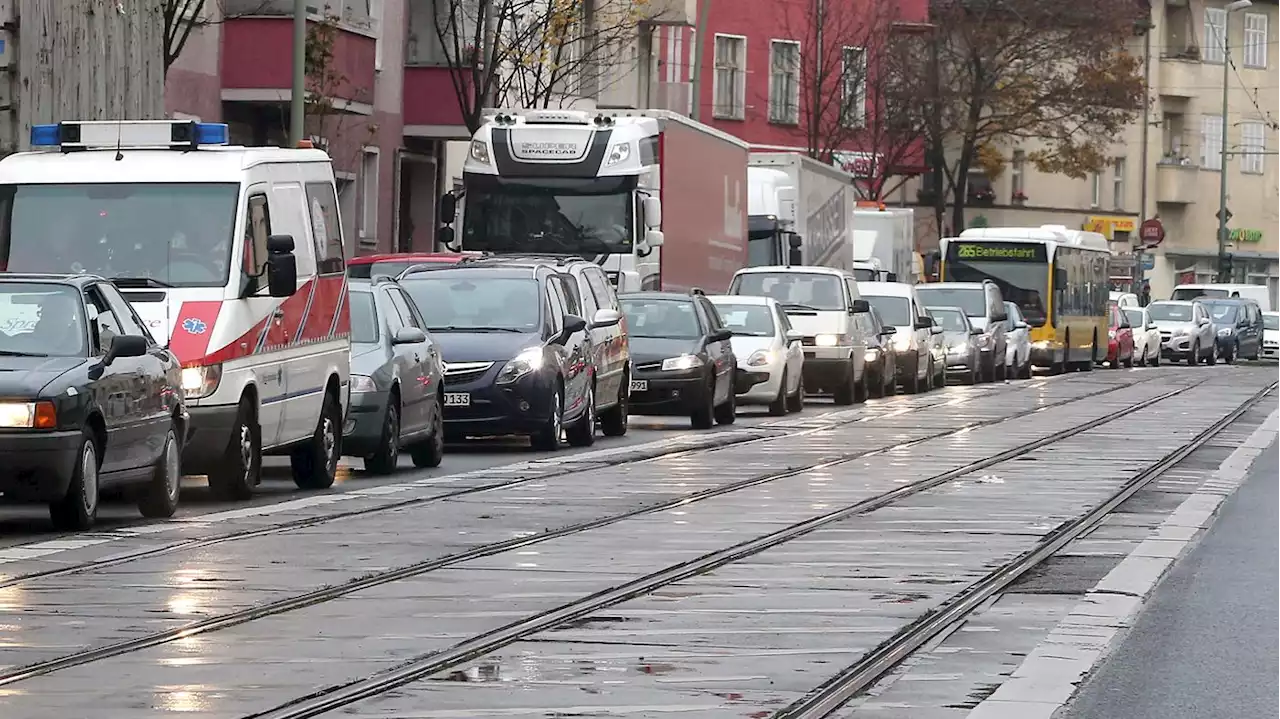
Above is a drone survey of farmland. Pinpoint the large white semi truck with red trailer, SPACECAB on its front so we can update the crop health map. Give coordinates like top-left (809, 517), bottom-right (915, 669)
top-left (439, 110), bottom-right (748, 292)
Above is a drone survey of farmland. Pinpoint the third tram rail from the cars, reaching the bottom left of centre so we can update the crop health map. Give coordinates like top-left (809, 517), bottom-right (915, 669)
top-left (209, 381), bottom-right (1218, 719)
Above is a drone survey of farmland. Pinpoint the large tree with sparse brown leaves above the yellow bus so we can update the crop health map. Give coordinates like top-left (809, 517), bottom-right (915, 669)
top-left (922, 0), bottom-right (1148, 232)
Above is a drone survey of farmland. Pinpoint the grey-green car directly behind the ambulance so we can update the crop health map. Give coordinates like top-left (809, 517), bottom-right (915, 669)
top-left (342, 276), bottom-right (444, 475)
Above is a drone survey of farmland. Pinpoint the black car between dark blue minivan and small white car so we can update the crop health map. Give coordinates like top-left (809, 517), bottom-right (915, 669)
top-left (618, 292), bottom-right (737, 430)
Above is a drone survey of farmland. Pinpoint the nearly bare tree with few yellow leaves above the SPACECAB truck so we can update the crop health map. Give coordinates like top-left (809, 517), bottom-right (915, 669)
top-left (433, 0), bottom-right (648, 132)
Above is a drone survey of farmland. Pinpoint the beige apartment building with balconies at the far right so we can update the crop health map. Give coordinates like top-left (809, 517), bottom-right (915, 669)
top-left (921, 0), bottom-right (1280, 306)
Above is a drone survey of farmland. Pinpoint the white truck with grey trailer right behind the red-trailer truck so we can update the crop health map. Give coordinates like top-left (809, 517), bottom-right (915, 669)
top-left (748, 152), bottom-right (858, 271)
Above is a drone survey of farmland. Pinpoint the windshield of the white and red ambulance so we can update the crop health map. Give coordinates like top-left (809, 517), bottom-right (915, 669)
top-left (0, 183), bottom-right (239, 287)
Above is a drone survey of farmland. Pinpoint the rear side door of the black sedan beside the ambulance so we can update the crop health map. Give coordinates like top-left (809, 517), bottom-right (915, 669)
top-left (93, 283), bottom-right (175, 467)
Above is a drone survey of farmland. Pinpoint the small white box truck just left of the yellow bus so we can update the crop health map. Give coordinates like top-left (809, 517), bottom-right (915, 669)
top-left (852, 202), bottom-right (920, 284)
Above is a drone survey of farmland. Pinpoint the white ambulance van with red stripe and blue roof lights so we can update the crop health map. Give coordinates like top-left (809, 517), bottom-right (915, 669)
top-left (0, 120), bottom-right (351, 499)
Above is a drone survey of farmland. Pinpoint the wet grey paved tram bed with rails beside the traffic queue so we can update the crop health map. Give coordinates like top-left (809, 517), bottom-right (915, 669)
top-left (0, 366), bottom-right (1276, 719)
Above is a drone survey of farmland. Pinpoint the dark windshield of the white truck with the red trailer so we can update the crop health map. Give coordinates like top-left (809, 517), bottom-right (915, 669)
top-left (462, 175), bottom-right (636, 256)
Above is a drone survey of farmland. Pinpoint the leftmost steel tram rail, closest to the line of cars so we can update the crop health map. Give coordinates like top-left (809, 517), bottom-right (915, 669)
top-left (0, 368), bottom-right (1100, 588)
